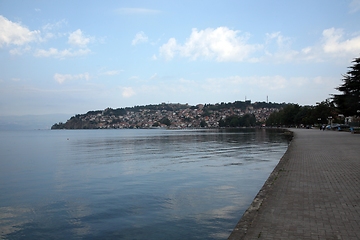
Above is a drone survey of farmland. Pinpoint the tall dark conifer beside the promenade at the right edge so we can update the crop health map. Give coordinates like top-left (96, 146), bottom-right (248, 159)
top-left (333, 58), bottom-right (360, 116)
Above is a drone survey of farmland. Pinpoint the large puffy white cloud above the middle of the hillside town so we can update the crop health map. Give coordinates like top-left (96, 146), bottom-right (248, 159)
top-left (159, 27), bottom-right (262, 62)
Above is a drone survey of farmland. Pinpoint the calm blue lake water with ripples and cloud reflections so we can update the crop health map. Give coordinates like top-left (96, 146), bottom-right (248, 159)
top-left (0, 129), bottom-right (288, 239)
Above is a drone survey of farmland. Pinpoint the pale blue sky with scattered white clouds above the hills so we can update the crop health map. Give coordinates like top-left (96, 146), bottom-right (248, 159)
top-left (0, 0), bottom-right (360, 116)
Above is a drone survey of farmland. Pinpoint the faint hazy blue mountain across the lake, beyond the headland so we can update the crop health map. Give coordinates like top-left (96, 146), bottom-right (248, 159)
top-left (0, 114), bottom-right (71, 130)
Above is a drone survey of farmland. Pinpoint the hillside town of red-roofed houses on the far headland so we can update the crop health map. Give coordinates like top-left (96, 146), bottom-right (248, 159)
top-left (52, 101), bottom-right (282, 129)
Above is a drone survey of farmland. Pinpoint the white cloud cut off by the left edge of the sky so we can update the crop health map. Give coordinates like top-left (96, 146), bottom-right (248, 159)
top-left (0, 15), bottom-right (40, 47)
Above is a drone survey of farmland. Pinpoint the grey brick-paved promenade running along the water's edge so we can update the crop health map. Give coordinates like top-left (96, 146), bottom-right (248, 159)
top-left (229, 129), bottom-right (360, 240)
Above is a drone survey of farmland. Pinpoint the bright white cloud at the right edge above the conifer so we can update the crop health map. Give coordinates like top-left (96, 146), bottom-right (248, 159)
top-left (322, 28), bottom-right (360, 56)
